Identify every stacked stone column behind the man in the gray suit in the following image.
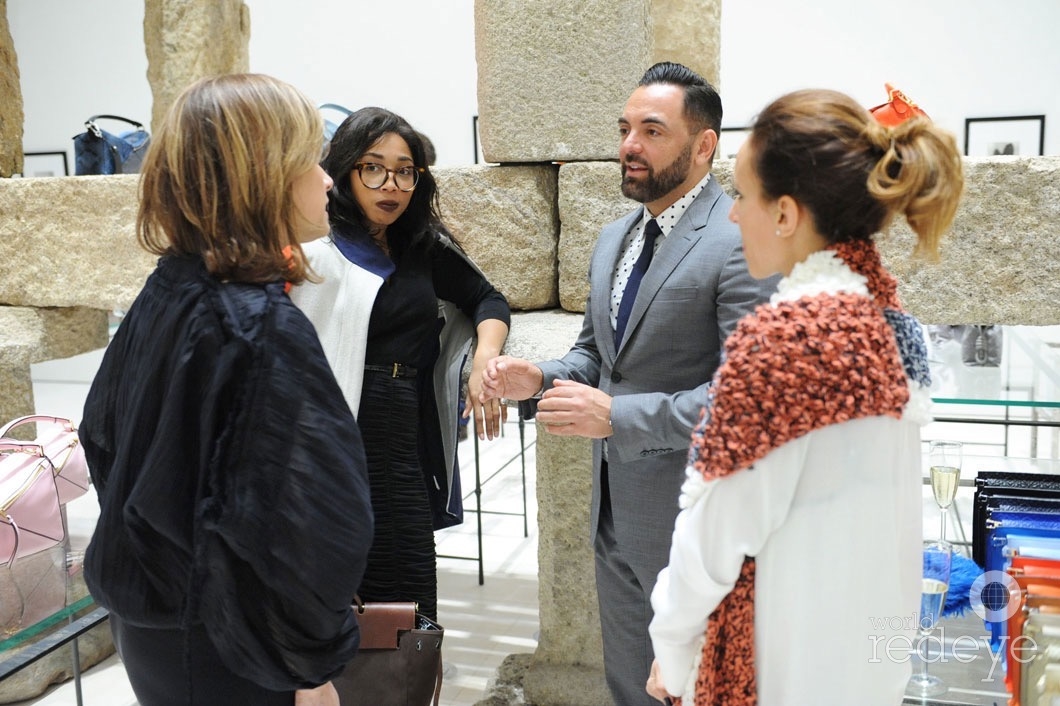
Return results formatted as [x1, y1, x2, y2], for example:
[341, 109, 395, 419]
[475, 0, 721, 706]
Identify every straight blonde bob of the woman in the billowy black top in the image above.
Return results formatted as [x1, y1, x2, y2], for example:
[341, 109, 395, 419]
[137, 73, 323, 284]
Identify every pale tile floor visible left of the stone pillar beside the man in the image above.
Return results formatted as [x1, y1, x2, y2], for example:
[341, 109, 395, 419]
[17, 351, 538, 706]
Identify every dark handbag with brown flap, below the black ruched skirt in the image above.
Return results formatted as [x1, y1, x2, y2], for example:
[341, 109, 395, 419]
[332, 598, 445, 706]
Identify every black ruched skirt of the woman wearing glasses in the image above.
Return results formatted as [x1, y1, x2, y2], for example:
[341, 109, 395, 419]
[357, 370, 438, 620]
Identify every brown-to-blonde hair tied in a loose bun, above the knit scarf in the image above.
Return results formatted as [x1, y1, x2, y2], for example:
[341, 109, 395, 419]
[749, 89, 965, 259]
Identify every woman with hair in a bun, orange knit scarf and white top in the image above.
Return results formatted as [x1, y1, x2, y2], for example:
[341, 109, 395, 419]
[648, 90, 964, 706]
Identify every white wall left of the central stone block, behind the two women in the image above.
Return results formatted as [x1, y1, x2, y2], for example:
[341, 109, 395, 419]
[7, 0, 477, 167]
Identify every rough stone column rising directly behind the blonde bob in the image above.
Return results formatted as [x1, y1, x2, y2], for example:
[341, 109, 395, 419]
[143, 0, 250, 128]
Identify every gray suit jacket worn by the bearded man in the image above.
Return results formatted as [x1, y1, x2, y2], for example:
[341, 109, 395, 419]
[540, 178, 777, 572]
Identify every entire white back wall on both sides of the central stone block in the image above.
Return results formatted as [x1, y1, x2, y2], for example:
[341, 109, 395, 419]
[7, 0, 1060, 169]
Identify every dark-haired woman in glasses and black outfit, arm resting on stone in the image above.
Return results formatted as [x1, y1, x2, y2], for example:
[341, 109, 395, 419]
[292, 107, 511, 619]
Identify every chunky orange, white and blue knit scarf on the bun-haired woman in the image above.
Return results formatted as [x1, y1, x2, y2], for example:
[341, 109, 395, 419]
[682, 242, 930, 706]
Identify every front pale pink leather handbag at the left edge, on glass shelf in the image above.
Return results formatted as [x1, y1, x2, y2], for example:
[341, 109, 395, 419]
[0, 440, 66, 566]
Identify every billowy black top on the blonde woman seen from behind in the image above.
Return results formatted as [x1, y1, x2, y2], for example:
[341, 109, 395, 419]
[78, 258, 372, 690]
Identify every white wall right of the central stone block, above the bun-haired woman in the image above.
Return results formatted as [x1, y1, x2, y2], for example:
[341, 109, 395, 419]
[721, 0, 1060, 155]
